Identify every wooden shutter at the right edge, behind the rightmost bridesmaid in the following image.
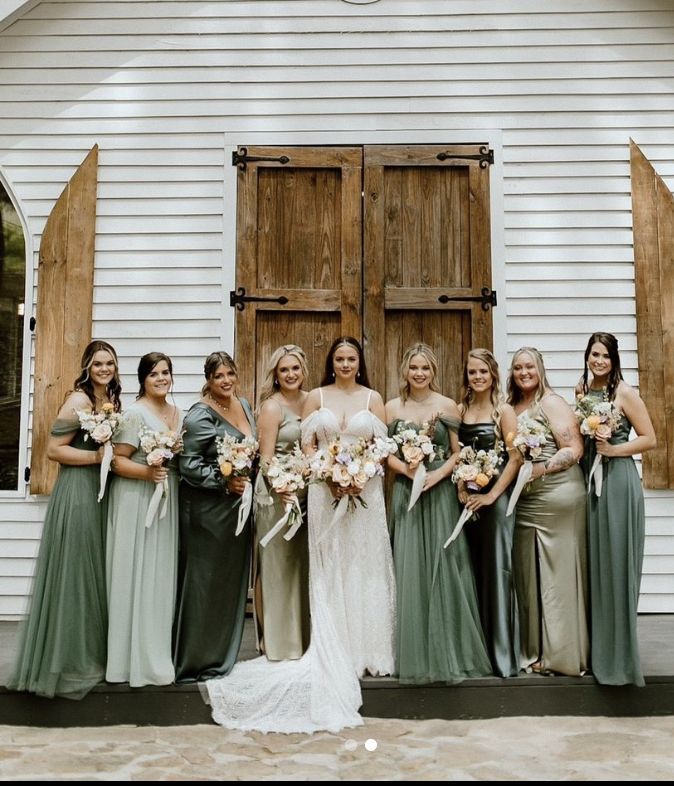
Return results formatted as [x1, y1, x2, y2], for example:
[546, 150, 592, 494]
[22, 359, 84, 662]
[630, 140, 674, 488]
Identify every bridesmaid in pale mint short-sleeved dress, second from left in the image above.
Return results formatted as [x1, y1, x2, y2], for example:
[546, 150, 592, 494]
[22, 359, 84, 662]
[105, 352, 182, 687]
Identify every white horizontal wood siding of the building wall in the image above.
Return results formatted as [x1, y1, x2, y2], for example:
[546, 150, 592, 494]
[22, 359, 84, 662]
[0, 0, 674, 617]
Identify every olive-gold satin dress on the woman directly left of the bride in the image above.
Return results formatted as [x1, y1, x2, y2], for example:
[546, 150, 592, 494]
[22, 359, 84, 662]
[255, 407, 310, 660]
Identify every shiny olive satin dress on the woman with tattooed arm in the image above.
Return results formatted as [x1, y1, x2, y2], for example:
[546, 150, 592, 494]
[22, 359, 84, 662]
[513, 406, 589, 676]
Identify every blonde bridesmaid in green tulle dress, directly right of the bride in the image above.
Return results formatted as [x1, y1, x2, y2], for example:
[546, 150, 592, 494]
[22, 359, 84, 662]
[386, 344, 491, 683]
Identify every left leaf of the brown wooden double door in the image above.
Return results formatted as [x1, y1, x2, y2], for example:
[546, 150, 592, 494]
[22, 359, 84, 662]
[234, 147, 362, 397]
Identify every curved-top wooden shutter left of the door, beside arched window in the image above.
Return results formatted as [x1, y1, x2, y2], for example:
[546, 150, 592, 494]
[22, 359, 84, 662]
[30, 145, 98, 494]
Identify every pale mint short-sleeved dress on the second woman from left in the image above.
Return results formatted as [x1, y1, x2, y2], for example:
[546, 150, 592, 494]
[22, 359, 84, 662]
[106, 402, 182, 687]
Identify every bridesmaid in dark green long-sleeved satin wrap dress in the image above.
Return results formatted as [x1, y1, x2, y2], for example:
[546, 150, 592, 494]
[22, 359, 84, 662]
[173, 352, 255, 682]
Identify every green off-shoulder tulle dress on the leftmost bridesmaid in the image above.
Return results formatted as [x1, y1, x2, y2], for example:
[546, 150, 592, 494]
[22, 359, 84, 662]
[7, 419, 107, 699]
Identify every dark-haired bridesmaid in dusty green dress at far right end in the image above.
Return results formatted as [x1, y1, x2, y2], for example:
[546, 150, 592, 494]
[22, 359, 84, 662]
[577, 333, 656, 685]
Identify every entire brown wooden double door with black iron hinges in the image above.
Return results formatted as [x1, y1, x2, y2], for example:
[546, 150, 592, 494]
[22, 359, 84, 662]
[230, 144, 496, 400]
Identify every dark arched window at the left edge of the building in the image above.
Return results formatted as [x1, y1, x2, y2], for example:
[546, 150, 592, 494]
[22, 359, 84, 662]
[0, 181, 26, 491]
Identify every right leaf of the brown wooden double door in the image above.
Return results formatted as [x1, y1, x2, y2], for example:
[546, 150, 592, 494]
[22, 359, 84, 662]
[364, 145, 492, 398]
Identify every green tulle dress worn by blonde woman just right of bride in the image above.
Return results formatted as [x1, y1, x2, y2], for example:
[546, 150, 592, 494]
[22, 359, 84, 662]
[389, 418, 492, 684]
